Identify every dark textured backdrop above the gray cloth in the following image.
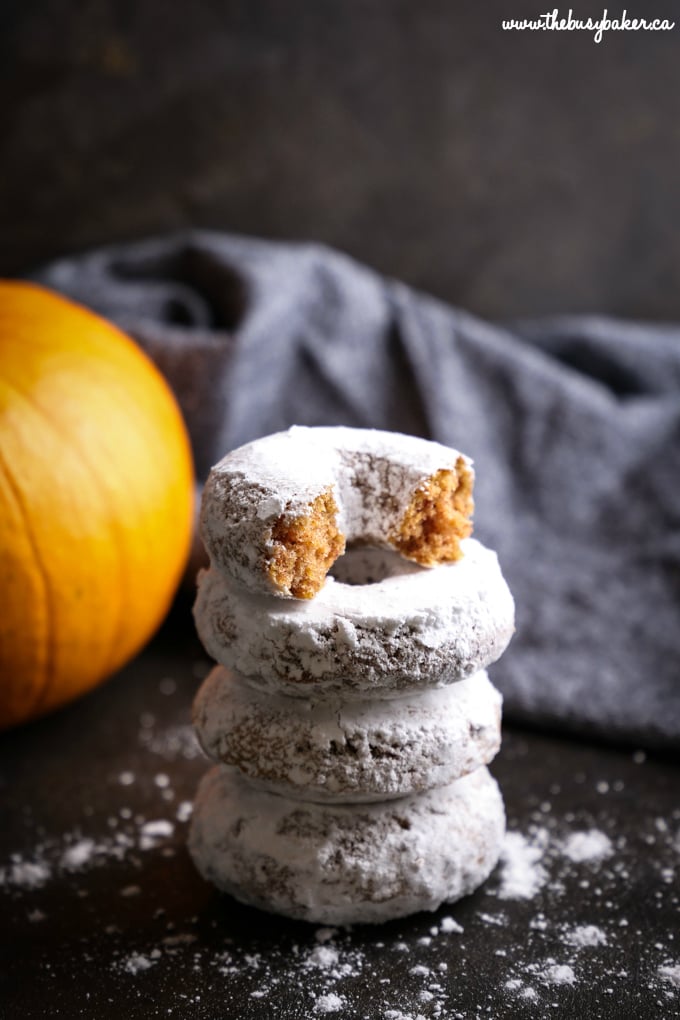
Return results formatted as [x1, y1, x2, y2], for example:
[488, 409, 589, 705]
[0, 0, 680, 319]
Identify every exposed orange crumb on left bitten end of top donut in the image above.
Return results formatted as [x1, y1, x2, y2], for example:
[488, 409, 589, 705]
[268, 490, 345, 599]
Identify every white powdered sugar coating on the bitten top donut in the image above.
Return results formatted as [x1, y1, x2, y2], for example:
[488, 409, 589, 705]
[201, 426, 472, 597]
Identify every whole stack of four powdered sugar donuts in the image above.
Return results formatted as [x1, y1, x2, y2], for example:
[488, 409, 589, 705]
[190, 427, 514, 924]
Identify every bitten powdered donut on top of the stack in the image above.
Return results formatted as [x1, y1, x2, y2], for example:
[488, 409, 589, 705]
[201, 425, 474, 599]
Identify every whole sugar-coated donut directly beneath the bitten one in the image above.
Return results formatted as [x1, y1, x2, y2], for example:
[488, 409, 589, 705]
[195, 539, 514, 700]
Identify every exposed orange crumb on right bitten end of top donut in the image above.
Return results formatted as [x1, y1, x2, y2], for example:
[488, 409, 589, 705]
[390, 457, 474, 566]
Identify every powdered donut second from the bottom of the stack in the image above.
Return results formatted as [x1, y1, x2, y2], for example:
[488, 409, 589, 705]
[194, 666, 502, 803]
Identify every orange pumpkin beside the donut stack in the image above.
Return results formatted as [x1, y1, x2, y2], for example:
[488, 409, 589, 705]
[0, 282, 194, 727]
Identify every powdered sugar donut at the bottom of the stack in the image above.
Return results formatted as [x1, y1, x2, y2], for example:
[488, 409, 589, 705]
[189, 765, 505, 924]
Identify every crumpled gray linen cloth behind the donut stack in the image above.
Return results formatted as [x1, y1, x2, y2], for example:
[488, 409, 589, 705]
[34, 233, 680, 748]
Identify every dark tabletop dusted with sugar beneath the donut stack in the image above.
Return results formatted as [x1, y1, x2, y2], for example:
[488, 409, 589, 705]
[0, 595, 680, 1020]
